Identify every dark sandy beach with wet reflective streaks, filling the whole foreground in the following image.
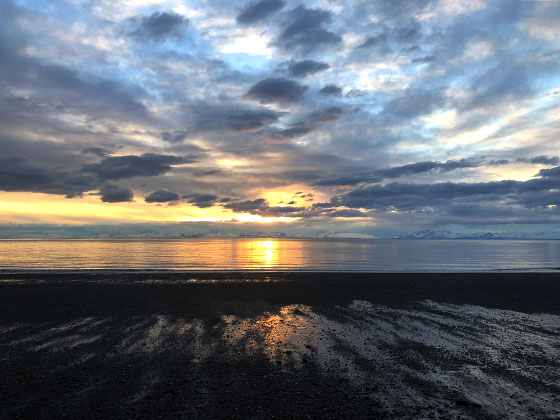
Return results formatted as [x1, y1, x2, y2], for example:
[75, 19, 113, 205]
[0, 273, 560, 419]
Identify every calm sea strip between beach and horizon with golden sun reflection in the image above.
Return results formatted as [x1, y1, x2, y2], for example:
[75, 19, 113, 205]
[0, 239, 560, 272]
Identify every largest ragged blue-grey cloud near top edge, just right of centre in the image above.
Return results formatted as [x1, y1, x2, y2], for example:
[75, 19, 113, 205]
[277, 6, 342, 51]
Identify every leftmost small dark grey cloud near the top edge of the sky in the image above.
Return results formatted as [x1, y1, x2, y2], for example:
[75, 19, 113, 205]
[131, 12, 189, 41]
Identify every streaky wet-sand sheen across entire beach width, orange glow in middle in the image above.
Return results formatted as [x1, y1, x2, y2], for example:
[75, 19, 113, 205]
[0, 300, 560, 418]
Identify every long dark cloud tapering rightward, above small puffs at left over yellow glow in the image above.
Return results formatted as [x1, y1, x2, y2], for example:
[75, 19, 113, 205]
[82, 153, 192, 181]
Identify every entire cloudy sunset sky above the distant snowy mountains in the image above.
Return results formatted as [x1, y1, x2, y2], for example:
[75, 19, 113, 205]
[0, 0, 560, 236]
